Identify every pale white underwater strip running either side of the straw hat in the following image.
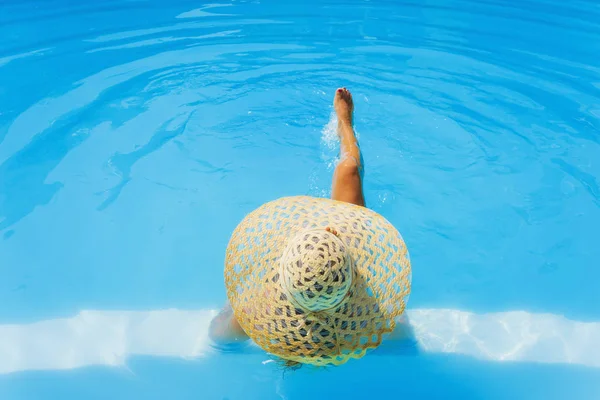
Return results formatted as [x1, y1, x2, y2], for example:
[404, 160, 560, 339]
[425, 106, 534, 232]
[0, 309, 600, 374]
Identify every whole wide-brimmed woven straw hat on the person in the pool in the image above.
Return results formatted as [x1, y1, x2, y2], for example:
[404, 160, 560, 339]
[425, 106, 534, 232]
[225, 196, 411, 366]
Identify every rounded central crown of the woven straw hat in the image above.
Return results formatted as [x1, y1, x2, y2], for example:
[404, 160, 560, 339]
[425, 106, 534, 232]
[281, 229, 353, 312]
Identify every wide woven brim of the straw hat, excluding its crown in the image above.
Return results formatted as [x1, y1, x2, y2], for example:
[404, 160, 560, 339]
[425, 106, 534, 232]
[225, 196, 411, 365]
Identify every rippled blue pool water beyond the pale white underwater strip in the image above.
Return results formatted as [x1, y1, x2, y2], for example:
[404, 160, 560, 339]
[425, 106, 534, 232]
[0, 0, 600, 328]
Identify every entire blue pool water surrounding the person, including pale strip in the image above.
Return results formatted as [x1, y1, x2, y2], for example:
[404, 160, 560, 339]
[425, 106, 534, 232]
[0, 0, 600, 400]
